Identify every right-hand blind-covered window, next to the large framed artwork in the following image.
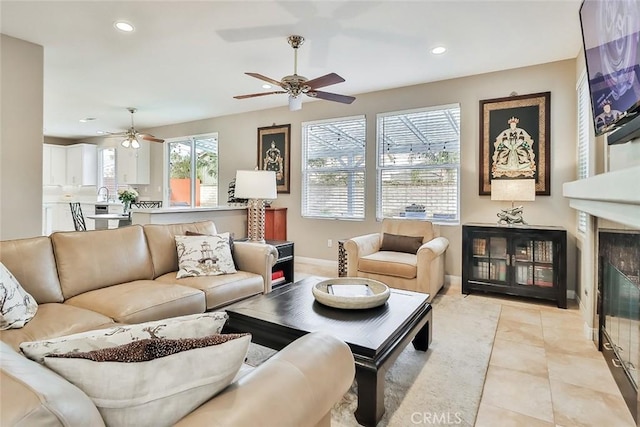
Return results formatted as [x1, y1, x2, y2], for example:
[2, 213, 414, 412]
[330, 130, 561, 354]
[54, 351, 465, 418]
[376, 104, 460, 223]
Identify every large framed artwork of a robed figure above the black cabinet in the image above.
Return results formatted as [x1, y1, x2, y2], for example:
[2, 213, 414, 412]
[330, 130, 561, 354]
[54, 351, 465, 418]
[479, 92, 551, 196]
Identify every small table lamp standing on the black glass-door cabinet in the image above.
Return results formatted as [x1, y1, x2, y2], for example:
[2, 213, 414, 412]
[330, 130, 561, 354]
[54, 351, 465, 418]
[491, 179, 536, 225]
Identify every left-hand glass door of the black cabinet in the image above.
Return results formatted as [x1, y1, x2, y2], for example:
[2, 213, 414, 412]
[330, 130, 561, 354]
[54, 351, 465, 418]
[472, 236, 508, 282]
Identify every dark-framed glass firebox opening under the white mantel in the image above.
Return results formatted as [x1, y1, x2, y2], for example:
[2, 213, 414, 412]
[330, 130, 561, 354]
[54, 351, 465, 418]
[598, 228, 640, 423]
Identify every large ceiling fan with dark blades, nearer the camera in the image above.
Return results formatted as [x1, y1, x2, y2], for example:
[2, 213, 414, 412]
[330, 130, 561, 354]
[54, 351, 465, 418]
[234, 35, 356, 111]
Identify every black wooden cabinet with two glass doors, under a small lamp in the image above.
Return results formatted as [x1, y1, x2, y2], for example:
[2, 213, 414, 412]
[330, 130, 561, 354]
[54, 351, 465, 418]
[462, 224, 567, 308]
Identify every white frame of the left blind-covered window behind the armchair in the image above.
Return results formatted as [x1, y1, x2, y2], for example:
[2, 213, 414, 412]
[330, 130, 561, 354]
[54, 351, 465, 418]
[300, 115, 367, 221]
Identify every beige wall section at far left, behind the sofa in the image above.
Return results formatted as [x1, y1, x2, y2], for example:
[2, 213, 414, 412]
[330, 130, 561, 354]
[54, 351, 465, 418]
[0, 34, 44, 240]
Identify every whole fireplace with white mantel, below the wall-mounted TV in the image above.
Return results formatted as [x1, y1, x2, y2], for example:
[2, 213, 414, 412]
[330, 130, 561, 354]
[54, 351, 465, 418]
[563, 164, 640, 427]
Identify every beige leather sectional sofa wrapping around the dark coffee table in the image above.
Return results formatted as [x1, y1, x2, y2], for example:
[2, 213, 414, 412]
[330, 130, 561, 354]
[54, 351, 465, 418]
[0, 221, 354, 426]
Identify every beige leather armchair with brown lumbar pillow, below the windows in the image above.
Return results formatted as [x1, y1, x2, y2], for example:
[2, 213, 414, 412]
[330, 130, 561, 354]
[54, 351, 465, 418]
[344, 219, 449, 301]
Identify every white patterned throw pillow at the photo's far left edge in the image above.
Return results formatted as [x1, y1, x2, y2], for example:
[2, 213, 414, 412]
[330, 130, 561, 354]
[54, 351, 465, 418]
[0, 262, 38, 330]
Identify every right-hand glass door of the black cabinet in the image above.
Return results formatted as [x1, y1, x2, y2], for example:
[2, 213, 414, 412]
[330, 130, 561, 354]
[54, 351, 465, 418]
[513, 239, 554, 288]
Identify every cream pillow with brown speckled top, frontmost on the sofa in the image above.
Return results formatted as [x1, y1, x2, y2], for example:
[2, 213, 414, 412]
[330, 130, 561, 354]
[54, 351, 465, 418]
[44, 334, 251, 426]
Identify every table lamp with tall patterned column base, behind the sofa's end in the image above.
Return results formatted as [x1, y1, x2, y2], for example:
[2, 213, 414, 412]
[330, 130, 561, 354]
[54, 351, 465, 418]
[235, 170, 278, 243]
